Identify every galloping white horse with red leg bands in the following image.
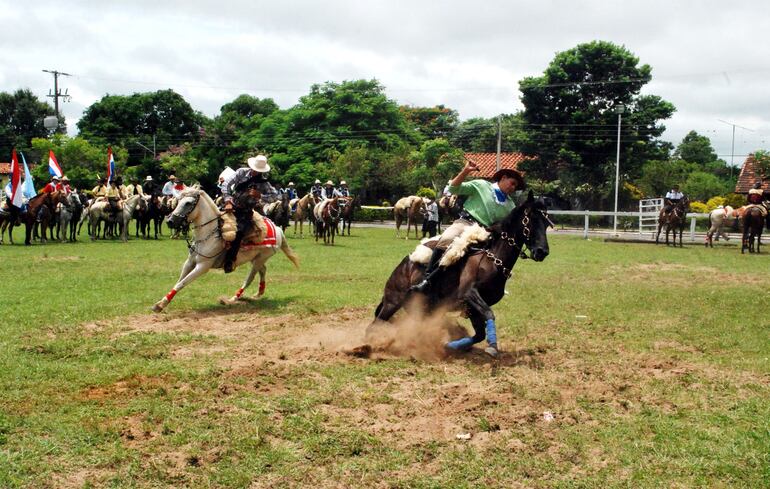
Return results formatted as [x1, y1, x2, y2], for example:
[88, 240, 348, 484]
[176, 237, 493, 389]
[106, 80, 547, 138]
[153, 188, 299, 312]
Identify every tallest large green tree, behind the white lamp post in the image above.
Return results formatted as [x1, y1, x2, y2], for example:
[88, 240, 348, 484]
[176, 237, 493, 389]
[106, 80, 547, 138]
[519, 41, 675, 205]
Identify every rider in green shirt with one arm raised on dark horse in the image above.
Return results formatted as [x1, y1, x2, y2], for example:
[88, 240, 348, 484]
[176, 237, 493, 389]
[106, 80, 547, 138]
[411, 160, 526, 292]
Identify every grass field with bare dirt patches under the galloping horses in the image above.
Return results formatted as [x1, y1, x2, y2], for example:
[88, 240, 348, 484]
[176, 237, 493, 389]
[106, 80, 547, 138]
[0, 229, 770, 487]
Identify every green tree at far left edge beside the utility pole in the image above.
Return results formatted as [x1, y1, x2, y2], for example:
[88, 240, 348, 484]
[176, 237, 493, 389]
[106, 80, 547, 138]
[0, 89, 55, 161]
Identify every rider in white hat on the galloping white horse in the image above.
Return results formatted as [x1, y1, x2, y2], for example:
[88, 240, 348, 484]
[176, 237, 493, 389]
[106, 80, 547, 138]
[222, 155, 279, 273]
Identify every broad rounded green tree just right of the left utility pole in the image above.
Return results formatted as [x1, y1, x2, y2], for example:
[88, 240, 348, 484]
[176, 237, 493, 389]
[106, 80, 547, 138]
[78, 90, 206, 165]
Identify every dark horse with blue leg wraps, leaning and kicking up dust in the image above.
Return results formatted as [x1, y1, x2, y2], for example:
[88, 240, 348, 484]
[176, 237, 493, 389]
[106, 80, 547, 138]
[372, 192, 553, 357]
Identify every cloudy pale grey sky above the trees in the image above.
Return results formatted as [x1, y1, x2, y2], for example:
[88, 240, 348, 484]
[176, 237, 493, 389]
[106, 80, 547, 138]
[0, 0, 770, 164]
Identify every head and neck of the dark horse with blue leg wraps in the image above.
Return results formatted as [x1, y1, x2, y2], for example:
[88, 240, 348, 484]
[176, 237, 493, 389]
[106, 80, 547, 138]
[492, 190, 554, 261]
